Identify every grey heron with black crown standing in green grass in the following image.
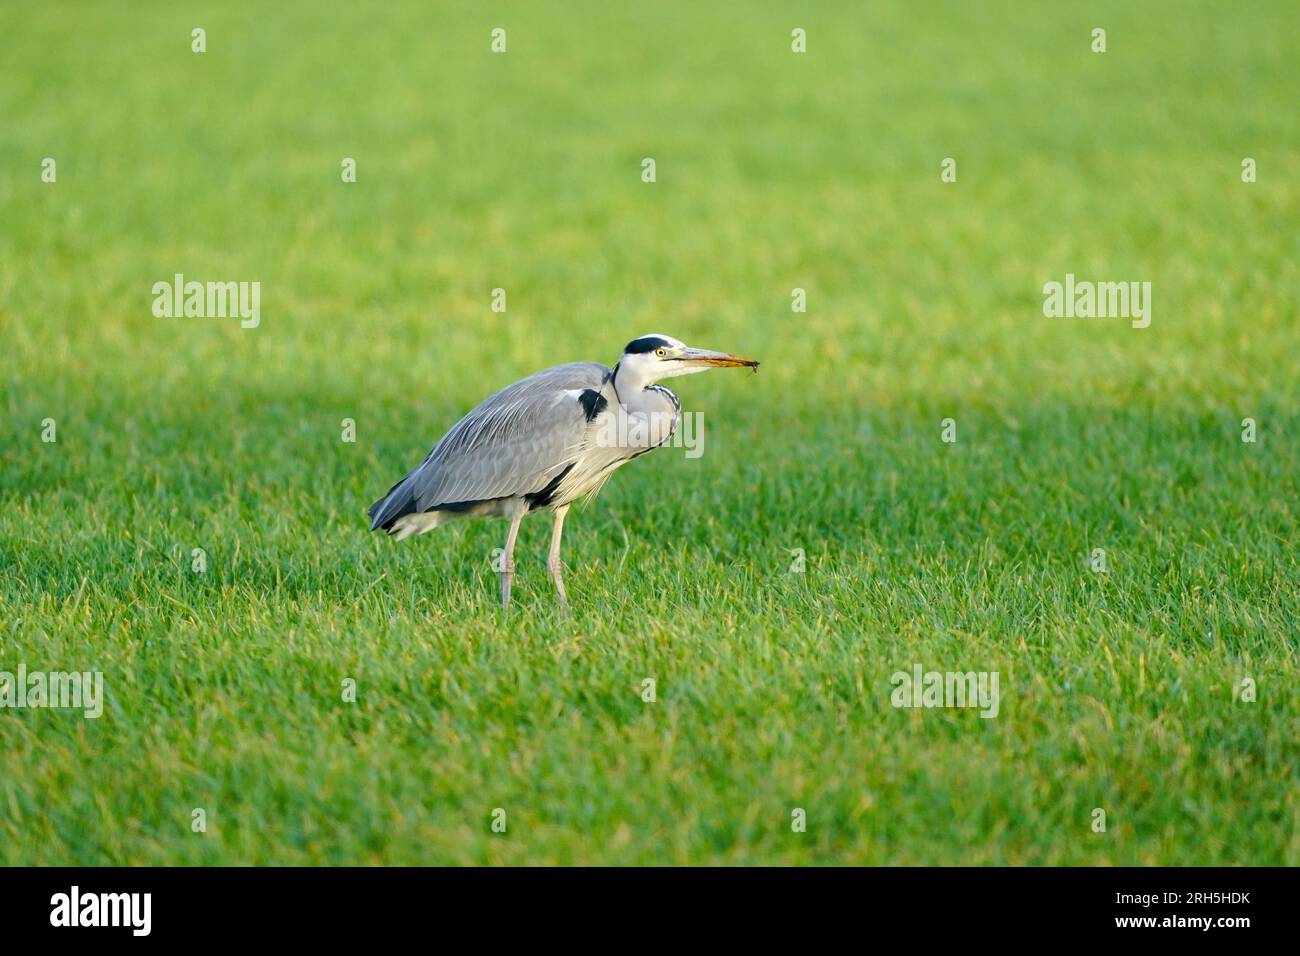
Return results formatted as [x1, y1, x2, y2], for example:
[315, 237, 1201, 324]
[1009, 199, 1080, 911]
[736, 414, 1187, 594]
[369, 334, 758, 609]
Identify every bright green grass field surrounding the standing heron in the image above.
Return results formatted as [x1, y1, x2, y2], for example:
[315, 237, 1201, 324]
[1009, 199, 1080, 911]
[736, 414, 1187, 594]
[0, 0, 1300, 865]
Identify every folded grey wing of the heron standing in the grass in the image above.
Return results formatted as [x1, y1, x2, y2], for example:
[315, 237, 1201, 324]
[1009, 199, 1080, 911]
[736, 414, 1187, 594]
[371, 362, 611, 528]
